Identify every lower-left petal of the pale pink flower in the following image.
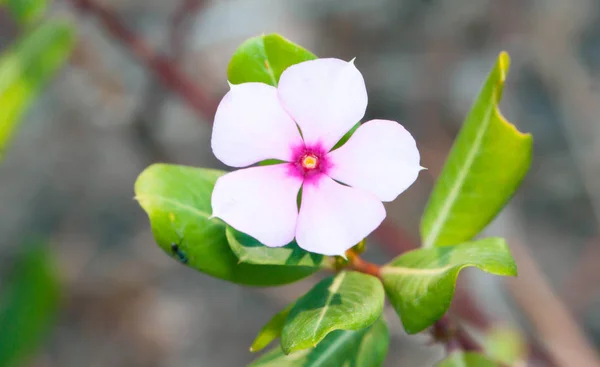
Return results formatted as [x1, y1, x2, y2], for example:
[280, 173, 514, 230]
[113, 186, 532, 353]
[212, 164, 302, 247]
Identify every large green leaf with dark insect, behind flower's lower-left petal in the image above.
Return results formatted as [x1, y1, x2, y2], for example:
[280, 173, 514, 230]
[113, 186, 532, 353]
[135, 164, 317, 286]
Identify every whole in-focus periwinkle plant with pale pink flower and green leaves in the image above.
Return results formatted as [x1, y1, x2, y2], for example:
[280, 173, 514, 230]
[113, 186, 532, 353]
[136, 35, 532, 367]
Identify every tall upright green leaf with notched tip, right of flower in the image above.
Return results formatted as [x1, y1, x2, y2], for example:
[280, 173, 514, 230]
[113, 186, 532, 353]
[421, 52, 532, 247]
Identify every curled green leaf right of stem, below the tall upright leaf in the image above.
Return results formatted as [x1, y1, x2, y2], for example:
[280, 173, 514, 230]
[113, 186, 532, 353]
[381, 238, 517, 334]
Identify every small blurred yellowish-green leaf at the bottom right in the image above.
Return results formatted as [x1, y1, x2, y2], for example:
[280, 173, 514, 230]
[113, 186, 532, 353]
[483, 326, 527, 366]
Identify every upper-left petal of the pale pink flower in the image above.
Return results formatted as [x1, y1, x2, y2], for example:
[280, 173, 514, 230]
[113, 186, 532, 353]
[211, 83, 302, 167]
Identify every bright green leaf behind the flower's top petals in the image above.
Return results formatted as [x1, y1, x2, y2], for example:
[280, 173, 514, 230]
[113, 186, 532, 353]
[227, 34, 317, 86]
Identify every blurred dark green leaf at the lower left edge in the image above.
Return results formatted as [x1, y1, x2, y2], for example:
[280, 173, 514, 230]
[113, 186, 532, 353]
[0, 247, 60, 367]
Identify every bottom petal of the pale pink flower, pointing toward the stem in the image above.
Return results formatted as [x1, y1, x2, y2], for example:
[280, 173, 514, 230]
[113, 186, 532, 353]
[296, 175, 385, 256]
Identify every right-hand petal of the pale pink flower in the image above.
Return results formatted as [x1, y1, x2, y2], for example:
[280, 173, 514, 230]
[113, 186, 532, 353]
[327, 120, 423, 201]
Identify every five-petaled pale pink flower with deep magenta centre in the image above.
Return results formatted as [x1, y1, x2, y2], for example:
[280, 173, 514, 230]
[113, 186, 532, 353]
[212, 59, 422, 255]
